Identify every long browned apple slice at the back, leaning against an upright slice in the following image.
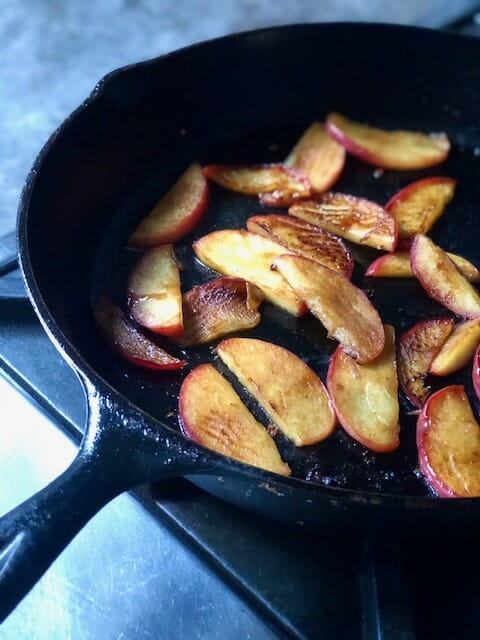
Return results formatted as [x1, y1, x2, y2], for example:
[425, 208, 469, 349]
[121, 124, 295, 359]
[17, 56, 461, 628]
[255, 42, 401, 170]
[203, 164, 312, 207]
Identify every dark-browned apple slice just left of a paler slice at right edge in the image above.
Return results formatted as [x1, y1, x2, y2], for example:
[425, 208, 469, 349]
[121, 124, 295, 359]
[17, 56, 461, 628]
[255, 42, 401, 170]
[397, 318, 454, 408]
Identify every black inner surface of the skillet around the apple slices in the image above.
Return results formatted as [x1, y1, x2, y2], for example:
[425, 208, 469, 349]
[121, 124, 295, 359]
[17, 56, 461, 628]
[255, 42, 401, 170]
[20, 25, 480, 496]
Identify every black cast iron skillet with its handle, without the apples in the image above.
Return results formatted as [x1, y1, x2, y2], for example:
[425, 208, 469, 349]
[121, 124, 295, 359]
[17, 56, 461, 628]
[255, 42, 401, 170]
[0, 24, 480, 617]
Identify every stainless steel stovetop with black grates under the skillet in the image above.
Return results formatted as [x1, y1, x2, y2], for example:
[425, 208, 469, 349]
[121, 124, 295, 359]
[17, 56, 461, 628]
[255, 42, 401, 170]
[0, 6, 480, 640]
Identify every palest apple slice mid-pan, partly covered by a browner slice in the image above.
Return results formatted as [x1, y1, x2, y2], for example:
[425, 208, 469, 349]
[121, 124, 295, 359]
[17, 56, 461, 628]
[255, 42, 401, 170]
[193, 229, 307, 316]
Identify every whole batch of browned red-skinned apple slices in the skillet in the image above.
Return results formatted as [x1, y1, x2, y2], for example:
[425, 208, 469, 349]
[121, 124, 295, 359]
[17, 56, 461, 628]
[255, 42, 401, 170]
[94, 113, 480, 497]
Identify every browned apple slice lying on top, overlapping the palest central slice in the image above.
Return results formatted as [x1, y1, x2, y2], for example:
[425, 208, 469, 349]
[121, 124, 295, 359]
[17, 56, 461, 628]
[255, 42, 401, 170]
[274, 255, 385, 364]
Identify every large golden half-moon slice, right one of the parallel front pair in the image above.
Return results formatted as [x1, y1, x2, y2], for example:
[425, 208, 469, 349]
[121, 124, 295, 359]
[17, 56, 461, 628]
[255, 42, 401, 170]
[216, 338, 335, 447]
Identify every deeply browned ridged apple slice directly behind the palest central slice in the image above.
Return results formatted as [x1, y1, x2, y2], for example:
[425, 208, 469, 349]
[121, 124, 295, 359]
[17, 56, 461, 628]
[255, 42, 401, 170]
[247, 214, 354, 278]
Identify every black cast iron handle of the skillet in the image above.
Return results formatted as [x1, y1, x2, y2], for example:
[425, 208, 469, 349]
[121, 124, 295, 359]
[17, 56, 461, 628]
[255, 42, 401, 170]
[0, 450, 123, 623]
